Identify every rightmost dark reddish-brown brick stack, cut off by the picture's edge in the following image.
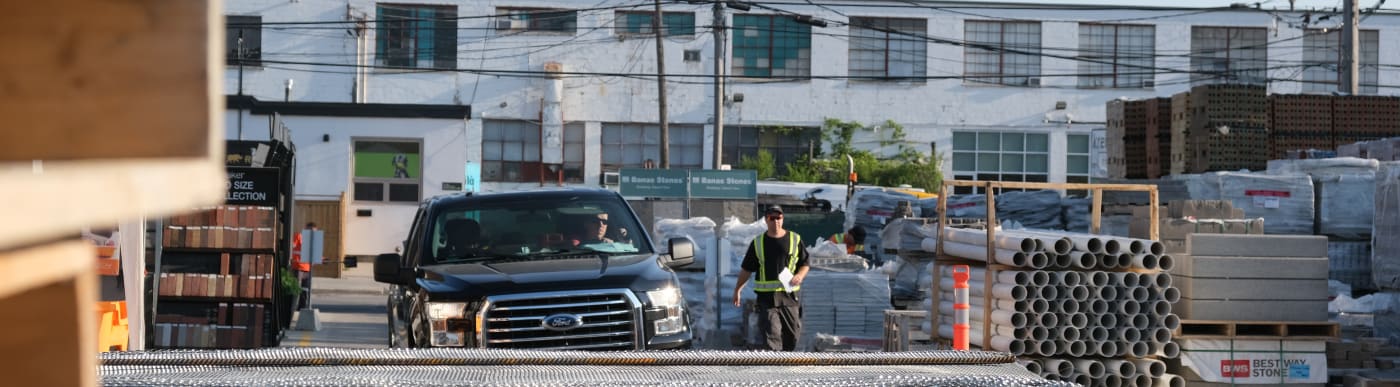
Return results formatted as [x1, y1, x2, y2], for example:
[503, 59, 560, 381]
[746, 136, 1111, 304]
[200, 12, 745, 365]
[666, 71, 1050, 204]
[1333, 95, 1400, 144]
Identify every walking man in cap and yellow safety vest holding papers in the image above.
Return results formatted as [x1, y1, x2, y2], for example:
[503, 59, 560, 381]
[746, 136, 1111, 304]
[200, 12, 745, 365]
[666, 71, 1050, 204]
[734, 206, 808, 351]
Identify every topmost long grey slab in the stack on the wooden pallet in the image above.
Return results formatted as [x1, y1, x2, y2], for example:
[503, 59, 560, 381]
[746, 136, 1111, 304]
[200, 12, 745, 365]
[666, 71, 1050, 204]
[1186, 234, 1327, 258]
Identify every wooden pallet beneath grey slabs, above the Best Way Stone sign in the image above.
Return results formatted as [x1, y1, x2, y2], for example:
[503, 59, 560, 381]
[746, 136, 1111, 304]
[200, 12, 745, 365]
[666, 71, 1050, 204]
[1172, 320, 1341, 339]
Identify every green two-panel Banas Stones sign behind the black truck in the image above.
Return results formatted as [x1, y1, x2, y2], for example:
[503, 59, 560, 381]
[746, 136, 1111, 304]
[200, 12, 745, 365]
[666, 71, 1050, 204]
[617, 168, 759, 201]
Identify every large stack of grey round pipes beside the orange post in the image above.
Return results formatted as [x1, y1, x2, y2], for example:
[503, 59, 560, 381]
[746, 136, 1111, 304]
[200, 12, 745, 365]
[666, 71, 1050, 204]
[924, 229, 1184, 387]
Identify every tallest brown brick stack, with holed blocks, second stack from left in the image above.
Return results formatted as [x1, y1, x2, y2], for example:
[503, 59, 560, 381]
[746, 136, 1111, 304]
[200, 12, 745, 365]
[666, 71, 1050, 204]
[1172, 84, 1268, 174]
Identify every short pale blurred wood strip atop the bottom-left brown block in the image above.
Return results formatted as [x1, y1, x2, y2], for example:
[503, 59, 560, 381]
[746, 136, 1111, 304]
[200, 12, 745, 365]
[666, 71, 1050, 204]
[0, 241, 97, 299]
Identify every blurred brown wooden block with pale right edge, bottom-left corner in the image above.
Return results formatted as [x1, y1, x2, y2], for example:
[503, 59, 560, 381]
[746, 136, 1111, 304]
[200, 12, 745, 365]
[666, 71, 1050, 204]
[0, 253, 98, 386]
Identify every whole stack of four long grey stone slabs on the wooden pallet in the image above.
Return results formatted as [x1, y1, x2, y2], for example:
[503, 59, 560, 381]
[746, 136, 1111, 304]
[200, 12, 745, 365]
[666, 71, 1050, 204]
[1172, 234, 1329, 321]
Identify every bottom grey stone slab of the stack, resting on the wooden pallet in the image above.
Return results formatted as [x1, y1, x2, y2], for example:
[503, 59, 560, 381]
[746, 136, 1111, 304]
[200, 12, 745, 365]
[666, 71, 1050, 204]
[1172, 299, 1327, 321]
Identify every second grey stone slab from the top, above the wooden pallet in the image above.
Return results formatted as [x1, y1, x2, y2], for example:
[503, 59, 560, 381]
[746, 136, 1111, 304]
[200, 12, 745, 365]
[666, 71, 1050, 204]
[1172, 255, 1327, 279]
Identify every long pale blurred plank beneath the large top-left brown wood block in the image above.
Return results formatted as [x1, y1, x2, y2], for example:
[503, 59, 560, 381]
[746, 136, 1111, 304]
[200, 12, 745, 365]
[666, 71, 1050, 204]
[0, 158, 228, 250]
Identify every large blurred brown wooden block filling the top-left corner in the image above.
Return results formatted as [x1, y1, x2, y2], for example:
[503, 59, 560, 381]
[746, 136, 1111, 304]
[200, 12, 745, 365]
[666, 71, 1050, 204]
[0, 0, 224, 160]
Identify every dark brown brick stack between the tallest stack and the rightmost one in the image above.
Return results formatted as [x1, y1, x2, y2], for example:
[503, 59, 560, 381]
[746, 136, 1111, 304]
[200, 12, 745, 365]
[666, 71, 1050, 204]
[1268, 94, 1336, 160]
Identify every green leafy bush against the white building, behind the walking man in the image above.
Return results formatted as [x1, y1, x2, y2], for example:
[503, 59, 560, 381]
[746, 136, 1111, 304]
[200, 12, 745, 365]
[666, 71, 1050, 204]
[772, 118, 942, 192]
